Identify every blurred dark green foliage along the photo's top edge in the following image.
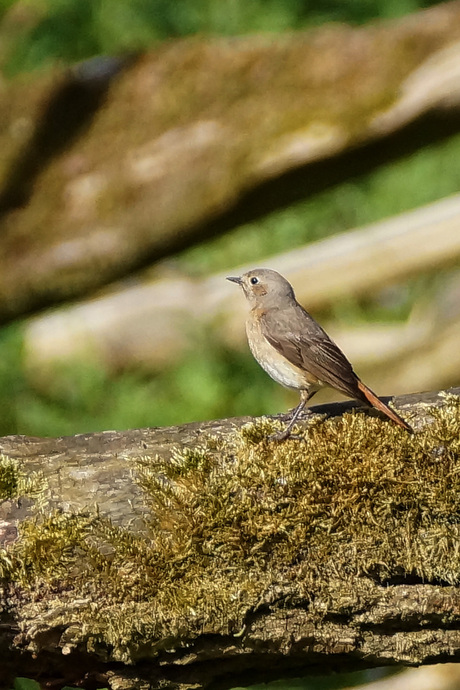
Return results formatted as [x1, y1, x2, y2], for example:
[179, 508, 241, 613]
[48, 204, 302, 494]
[0, 0, 450, 73]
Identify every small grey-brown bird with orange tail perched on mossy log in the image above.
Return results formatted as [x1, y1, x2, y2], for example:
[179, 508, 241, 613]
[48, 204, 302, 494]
[227, 268, 412, 440]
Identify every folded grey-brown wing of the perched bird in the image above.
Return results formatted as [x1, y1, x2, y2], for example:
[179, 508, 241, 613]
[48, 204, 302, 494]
[260, 305, 362, 398]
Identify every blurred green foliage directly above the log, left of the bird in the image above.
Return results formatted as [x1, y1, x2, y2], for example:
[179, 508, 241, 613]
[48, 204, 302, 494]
[0, 324, 296, 436]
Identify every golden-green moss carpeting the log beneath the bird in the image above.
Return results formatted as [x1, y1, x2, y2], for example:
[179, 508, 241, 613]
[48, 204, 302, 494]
[4, 396, 460, 662]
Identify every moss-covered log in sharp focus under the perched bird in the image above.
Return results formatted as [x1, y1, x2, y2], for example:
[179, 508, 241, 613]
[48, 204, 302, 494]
[0, 388, 460, 690]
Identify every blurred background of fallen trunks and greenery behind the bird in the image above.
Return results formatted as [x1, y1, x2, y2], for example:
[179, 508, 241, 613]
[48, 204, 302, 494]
[4, 0, 460, 688]
